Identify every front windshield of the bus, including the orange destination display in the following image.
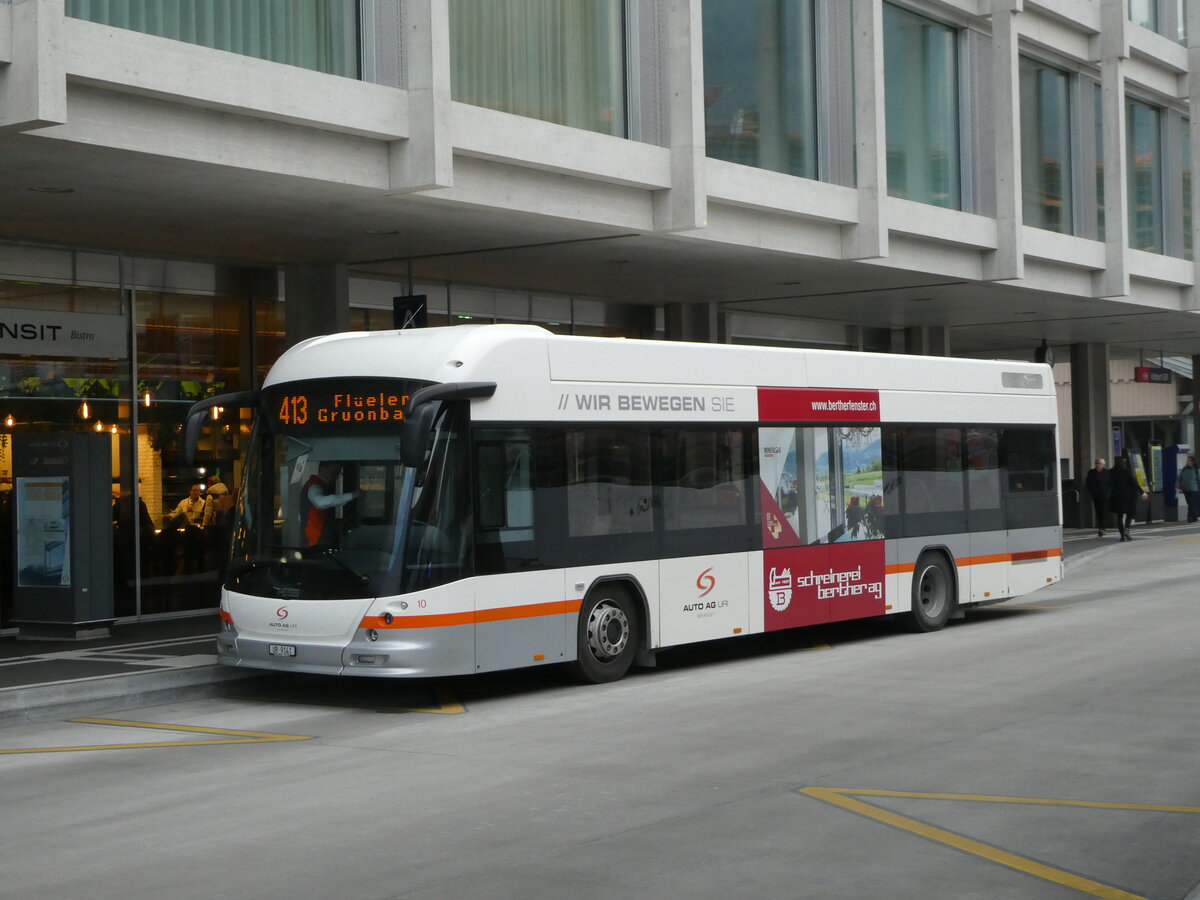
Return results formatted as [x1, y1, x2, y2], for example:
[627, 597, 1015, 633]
[226, 379, 472, 600]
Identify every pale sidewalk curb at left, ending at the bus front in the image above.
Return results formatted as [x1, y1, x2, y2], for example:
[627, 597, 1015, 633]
[0, 664, 264, 727]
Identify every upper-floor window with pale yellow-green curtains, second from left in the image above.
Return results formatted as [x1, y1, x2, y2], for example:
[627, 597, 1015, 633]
[450, 0, 628, 137]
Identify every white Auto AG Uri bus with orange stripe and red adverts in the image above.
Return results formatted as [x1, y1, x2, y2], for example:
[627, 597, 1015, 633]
[188, 325, 1062, 683]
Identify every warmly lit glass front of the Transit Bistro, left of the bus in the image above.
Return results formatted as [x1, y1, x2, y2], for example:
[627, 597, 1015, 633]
[0, 251, 274, 628]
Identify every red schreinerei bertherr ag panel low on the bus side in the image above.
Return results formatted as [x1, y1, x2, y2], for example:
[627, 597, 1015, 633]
[762, 541, 887, 631]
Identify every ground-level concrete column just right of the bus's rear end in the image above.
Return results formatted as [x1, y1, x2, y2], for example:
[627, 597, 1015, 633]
[1060, 343, 1114, 528]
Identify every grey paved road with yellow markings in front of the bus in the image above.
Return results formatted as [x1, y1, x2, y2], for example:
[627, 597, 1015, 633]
[0, 533, 1200, 900]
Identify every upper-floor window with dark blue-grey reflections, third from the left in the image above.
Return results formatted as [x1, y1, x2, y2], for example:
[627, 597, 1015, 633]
[702, 0, 817, 178]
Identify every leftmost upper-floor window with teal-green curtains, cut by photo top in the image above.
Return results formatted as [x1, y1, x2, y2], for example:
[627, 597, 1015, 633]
[66, 0, 360, 78]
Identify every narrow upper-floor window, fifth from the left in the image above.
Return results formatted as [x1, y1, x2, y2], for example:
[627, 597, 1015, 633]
[1020, 58, 1074, 234]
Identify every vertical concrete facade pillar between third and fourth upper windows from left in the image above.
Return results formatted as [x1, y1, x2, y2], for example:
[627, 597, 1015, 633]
[841, 0, 888, 259]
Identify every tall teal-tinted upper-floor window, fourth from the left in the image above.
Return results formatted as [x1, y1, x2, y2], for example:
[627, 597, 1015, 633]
[883, 4, 962, 209]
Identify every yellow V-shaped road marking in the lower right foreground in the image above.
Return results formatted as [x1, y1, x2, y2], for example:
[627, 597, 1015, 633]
[799, 787, 1200, 900]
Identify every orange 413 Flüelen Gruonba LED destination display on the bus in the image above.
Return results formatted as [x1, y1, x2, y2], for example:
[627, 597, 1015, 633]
[265, 380, 421, 432]
